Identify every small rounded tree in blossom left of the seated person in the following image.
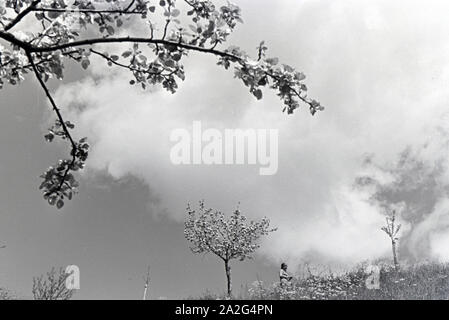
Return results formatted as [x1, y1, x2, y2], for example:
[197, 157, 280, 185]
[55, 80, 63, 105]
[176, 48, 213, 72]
[184, 201, 276, 296]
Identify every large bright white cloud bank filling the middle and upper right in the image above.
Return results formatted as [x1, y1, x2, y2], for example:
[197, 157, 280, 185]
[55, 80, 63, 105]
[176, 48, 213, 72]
[57, 1, 449, 263]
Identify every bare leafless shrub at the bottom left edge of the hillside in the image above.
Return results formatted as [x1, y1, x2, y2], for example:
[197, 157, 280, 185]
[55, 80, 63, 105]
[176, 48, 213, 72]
[33, 267, 74, 300]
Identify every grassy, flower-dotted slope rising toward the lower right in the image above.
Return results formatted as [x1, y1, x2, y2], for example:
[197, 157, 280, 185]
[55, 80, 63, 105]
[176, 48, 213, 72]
[194, 263, 449, 300]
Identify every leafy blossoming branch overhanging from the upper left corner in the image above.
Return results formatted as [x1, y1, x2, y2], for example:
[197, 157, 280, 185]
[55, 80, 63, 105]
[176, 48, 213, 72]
[0, 0, 324, 208]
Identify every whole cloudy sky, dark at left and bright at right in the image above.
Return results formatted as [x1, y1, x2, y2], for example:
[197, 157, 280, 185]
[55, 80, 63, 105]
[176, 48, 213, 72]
[0, 0, 449, 299]
